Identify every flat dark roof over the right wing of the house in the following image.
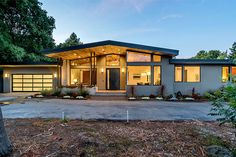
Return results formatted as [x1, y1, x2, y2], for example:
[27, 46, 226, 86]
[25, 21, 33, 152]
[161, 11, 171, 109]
[169, 59, 236, 65]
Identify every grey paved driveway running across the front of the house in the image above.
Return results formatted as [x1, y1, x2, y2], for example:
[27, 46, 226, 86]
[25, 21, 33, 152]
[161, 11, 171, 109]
[2, 99, 215, 121]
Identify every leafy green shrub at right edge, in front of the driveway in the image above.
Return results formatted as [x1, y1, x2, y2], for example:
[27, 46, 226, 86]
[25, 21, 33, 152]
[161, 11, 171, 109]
[210, 83, 236, 136]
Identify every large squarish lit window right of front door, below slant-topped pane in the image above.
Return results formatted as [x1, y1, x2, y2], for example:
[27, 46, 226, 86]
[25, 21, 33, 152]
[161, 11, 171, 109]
[128, 66, 151, 85]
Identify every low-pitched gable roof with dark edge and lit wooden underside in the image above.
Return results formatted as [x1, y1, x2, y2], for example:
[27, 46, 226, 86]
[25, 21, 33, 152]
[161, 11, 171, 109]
[42, 40, 179, 60]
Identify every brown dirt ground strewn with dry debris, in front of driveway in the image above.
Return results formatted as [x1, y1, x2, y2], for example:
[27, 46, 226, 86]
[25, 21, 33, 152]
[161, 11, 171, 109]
[5, 119, 236, 157]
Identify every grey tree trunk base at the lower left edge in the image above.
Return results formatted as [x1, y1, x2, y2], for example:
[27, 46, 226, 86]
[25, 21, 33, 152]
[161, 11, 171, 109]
[0, 107, 12, 157]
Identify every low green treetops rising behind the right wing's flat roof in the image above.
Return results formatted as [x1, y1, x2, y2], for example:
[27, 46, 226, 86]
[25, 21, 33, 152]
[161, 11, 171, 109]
[192, 50, 228, 59]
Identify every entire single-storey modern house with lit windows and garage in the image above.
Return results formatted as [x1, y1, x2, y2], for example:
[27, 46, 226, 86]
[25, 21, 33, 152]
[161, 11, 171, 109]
[0, 40, 236, 96]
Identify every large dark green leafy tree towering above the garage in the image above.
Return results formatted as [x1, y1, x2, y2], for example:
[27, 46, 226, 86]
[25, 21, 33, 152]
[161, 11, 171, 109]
[0, 0, 55, 62]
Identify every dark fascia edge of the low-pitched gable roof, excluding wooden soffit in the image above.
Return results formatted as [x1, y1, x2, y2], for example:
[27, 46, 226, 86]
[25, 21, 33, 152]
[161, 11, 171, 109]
[41, 40, 179, 56]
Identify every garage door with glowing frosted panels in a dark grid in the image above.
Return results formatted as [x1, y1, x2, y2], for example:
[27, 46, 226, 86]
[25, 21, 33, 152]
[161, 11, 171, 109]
[12, 74, 53, 92]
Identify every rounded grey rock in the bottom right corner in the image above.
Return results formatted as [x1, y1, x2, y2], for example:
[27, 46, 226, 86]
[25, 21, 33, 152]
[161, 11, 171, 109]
[206, 145, 233, 157]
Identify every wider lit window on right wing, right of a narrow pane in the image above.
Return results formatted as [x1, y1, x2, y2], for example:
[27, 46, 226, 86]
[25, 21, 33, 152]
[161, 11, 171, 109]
[184, 66, 200, 82]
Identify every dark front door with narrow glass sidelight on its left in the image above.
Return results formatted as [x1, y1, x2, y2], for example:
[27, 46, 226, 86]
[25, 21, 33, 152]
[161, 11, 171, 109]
[106, 68, 120, 90]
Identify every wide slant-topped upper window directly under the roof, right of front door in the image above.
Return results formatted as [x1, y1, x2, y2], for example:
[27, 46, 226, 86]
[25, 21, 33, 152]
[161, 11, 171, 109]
[127, 52, 151, 62]
